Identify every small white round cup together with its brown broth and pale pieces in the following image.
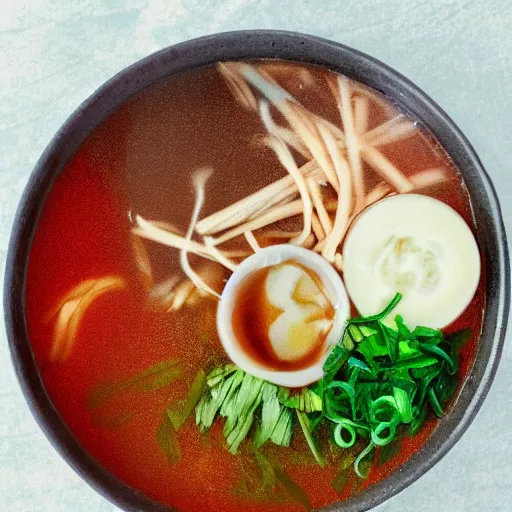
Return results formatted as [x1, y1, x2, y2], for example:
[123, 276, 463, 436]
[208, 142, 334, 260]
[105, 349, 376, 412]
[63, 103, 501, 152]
[217, 244, 349, 387]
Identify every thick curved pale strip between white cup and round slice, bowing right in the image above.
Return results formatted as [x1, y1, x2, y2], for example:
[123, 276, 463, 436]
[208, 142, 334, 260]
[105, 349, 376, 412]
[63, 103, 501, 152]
[320, 122, 352, 263]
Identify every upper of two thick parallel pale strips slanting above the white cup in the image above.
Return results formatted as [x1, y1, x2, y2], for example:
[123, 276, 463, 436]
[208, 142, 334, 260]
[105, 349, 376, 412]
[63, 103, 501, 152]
[196, 161, 319, 235]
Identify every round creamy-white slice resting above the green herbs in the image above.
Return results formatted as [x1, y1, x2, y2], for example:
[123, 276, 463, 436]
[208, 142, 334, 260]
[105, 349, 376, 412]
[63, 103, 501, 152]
[343, 194, 480, 328]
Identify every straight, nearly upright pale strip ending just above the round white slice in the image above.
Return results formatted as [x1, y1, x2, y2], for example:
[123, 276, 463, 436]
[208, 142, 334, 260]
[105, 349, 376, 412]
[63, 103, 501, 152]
[338, 76, 365, 210]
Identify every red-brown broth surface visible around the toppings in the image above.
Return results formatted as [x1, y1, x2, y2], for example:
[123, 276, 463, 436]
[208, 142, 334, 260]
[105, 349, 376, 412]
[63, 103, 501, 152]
[26, 64, 485, 512]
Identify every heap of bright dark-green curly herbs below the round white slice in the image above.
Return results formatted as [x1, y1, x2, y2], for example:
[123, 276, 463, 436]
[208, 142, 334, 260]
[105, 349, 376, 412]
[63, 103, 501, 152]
[314, 295, 467, 483]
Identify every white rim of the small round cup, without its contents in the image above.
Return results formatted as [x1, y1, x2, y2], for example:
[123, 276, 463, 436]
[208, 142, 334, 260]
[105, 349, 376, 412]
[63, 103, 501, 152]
[217, 244, 350, 388]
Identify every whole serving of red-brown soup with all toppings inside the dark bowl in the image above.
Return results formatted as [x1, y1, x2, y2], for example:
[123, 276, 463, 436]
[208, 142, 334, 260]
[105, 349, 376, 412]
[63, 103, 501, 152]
[26, 61, 485, 512]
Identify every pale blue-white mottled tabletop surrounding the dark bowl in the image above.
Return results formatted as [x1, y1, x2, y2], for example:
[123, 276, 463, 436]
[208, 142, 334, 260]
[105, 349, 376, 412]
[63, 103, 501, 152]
[0, 0, 512, 512]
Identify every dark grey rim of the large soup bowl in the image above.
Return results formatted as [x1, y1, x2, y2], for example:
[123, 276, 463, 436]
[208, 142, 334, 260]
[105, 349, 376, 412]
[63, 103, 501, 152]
[4, 30, 510, 512]
